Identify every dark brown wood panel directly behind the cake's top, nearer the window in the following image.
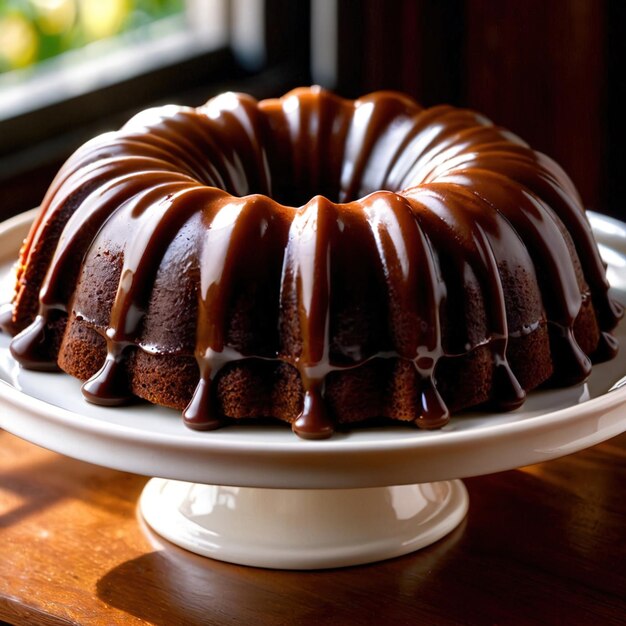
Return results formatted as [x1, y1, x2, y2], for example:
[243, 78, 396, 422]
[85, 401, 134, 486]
[337, 0, 463, 105]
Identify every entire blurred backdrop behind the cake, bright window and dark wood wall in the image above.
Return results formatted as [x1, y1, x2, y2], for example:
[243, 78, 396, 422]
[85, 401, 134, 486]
[0, 0, 626, 219]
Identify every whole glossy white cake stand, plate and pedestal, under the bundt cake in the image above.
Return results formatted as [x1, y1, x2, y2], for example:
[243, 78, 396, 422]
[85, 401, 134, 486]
[0, 207, 626, 569]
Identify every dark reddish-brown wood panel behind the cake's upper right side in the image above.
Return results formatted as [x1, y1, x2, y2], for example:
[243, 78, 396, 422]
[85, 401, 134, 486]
[465, 0, 606, 210]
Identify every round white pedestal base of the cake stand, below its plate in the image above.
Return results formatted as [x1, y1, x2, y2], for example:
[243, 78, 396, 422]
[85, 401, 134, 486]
[140, 478, 469, 570]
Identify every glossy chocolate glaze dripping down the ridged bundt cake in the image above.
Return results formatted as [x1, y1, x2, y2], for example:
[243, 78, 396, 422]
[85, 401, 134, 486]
[2, 88, 622, 438]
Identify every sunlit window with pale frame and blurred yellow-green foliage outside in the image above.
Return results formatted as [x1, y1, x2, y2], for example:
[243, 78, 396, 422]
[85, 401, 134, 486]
[0, 0, 228, 147]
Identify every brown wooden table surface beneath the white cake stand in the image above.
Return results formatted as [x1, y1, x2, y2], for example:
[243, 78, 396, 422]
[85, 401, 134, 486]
[0, 431, 626, 626]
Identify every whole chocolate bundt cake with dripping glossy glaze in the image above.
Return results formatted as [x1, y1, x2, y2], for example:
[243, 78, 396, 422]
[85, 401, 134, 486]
[3, 87, 622, 438]
